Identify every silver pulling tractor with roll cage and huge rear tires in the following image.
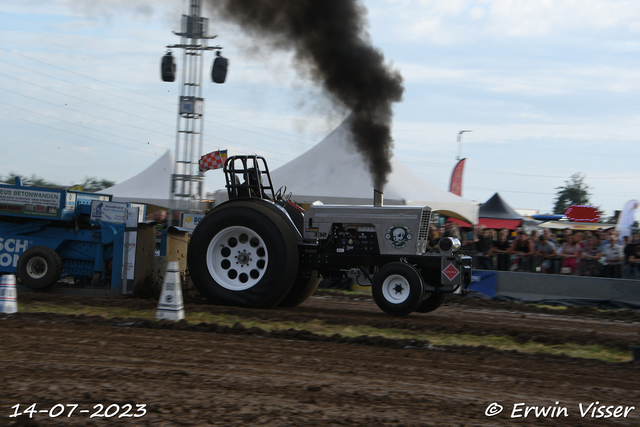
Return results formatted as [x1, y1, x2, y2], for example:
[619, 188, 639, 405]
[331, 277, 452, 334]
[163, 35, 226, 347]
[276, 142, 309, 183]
[187, 155, 472, 316]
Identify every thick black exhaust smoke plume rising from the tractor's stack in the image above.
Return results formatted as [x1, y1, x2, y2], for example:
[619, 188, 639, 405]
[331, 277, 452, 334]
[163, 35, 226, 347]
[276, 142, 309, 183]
[206, 0, 404, 190]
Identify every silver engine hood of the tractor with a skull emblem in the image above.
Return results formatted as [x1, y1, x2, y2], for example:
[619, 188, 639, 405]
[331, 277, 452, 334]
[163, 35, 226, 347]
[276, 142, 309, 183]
[303, 205, 431, 255]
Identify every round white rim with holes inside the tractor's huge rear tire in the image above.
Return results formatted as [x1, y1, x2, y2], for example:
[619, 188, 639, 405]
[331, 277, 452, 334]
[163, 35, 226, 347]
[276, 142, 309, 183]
[207, 226, 269, 291]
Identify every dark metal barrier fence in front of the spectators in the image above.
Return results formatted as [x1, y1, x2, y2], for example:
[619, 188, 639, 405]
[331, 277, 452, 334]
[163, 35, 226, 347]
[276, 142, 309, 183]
[464, 250, 640, 280]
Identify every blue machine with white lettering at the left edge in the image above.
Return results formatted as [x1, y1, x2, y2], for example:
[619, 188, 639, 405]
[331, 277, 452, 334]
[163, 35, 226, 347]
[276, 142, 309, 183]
[0, 179, 138, 295]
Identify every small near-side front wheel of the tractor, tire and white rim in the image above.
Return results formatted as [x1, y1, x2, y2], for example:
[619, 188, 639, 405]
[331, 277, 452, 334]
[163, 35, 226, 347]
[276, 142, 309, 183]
[371, 262, 424, 316]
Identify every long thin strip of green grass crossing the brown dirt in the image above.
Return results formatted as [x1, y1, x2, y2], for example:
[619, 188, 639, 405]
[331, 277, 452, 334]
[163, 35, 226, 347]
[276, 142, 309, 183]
[13, 302, 632, 362]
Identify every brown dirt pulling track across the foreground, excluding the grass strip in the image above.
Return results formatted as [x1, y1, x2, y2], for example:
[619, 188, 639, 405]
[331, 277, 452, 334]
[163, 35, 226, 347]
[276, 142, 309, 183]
[0, 293, 640, 426]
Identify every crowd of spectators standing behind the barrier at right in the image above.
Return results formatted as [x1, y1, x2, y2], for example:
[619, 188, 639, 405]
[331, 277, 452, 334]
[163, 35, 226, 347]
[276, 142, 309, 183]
[429, 224, 640, 279]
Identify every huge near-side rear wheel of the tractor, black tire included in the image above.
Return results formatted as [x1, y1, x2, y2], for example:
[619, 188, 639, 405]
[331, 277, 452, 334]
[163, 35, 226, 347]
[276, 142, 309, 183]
[187, 200, 298, 308]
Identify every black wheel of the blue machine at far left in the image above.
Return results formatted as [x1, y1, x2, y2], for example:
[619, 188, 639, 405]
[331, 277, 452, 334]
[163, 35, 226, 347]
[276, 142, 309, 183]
[16, 246, 62, 289]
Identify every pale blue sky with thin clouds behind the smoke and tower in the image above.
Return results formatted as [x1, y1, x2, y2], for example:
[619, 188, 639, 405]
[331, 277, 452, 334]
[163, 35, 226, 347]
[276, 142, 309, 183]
[0, 0, 640, 216]
